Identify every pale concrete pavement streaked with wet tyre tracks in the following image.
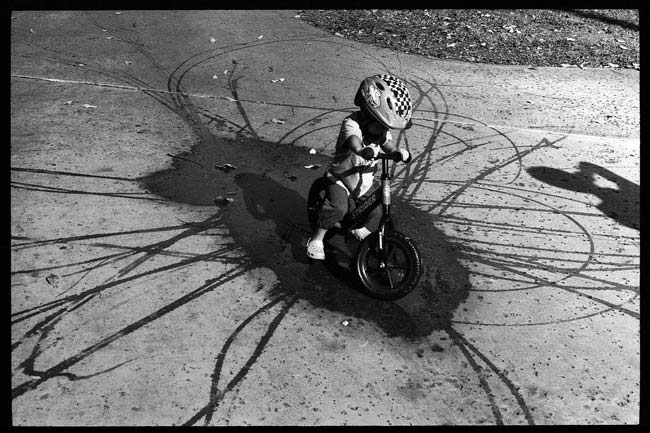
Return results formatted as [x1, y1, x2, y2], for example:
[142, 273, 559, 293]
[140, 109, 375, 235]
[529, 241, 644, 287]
[11, 10, 640, 425]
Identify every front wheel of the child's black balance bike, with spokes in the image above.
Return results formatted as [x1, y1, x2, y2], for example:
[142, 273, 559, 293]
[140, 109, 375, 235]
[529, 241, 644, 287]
[355, 231, 422, 301]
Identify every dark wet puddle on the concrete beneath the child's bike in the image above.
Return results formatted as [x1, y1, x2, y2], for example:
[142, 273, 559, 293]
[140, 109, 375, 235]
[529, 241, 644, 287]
[140, 137, 469, 339]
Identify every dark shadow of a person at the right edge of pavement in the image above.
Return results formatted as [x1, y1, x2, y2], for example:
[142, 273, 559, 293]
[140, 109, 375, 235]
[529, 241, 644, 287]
[526, 162, 641, 230]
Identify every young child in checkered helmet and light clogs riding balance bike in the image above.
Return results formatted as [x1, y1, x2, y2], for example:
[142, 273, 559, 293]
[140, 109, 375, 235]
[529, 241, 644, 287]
[307, 75, 411, 260]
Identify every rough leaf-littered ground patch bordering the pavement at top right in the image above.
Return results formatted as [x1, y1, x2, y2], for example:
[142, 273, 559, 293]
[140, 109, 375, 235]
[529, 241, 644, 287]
[299, 9, 640, 70]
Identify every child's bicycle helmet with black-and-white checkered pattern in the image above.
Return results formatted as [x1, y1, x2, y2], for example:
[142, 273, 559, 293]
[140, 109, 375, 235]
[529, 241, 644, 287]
[354, 74, 411, 129]
